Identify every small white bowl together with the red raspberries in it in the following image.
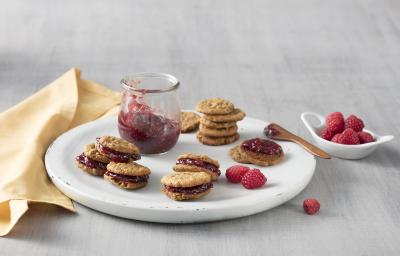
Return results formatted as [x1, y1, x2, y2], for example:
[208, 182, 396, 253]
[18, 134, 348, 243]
[301, 112, 393, 159]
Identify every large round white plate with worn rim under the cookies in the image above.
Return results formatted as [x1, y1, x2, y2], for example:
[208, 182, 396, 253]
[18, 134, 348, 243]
[45, 117, 316, 223]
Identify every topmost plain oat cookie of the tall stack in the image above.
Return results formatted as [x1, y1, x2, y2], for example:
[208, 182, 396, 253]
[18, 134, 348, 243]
[196, 98, 235, 115]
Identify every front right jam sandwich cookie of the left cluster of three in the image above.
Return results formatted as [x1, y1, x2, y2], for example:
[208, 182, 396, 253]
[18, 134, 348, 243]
[104, 162, 150, 189]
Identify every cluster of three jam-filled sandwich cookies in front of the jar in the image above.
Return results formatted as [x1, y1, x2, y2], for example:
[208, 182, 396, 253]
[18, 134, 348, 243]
[75, 136, 150, 189]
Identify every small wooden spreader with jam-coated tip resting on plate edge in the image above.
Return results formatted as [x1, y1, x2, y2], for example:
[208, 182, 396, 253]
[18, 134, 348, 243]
[264, 123, 331, 159]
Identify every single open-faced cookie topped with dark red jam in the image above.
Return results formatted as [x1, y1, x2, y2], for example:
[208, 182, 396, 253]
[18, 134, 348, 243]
[230, 138, 284, 166]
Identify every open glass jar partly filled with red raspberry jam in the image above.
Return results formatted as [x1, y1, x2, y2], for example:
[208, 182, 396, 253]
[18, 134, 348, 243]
[118, 73, 181, 154]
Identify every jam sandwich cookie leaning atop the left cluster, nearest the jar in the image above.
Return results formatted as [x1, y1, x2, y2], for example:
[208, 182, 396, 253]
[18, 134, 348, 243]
[96, 136, 140, 163]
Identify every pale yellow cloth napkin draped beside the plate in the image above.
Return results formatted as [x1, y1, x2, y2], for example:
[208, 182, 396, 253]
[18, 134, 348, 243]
[0, 69, 120, 236]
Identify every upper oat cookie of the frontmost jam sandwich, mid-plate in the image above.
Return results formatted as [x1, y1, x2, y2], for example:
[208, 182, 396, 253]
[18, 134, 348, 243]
[161, 172, 211, 188]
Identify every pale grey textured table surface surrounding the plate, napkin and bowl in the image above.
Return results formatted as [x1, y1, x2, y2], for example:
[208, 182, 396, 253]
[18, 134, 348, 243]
[0, 0, 400, 255]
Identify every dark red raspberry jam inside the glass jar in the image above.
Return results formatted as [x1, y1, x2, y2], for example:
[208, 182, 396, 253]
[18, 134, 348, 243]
[118, 96, 180, 154]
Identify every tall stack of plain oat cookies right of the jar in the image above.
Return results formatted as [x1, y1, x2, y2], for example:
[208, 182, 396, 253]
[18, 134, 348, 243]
[196, 98, 246, 146]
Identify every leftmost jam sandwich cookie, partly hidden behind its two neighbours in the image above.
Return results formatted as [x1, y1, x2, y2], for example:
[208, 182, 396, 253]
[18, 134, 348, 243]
[75, 143, 110, 176]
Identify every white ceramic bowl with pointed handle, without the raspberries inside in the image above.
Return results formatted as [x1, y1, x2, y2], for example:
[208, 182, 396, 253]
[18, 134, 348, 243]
[301, 112, 393, 159]
